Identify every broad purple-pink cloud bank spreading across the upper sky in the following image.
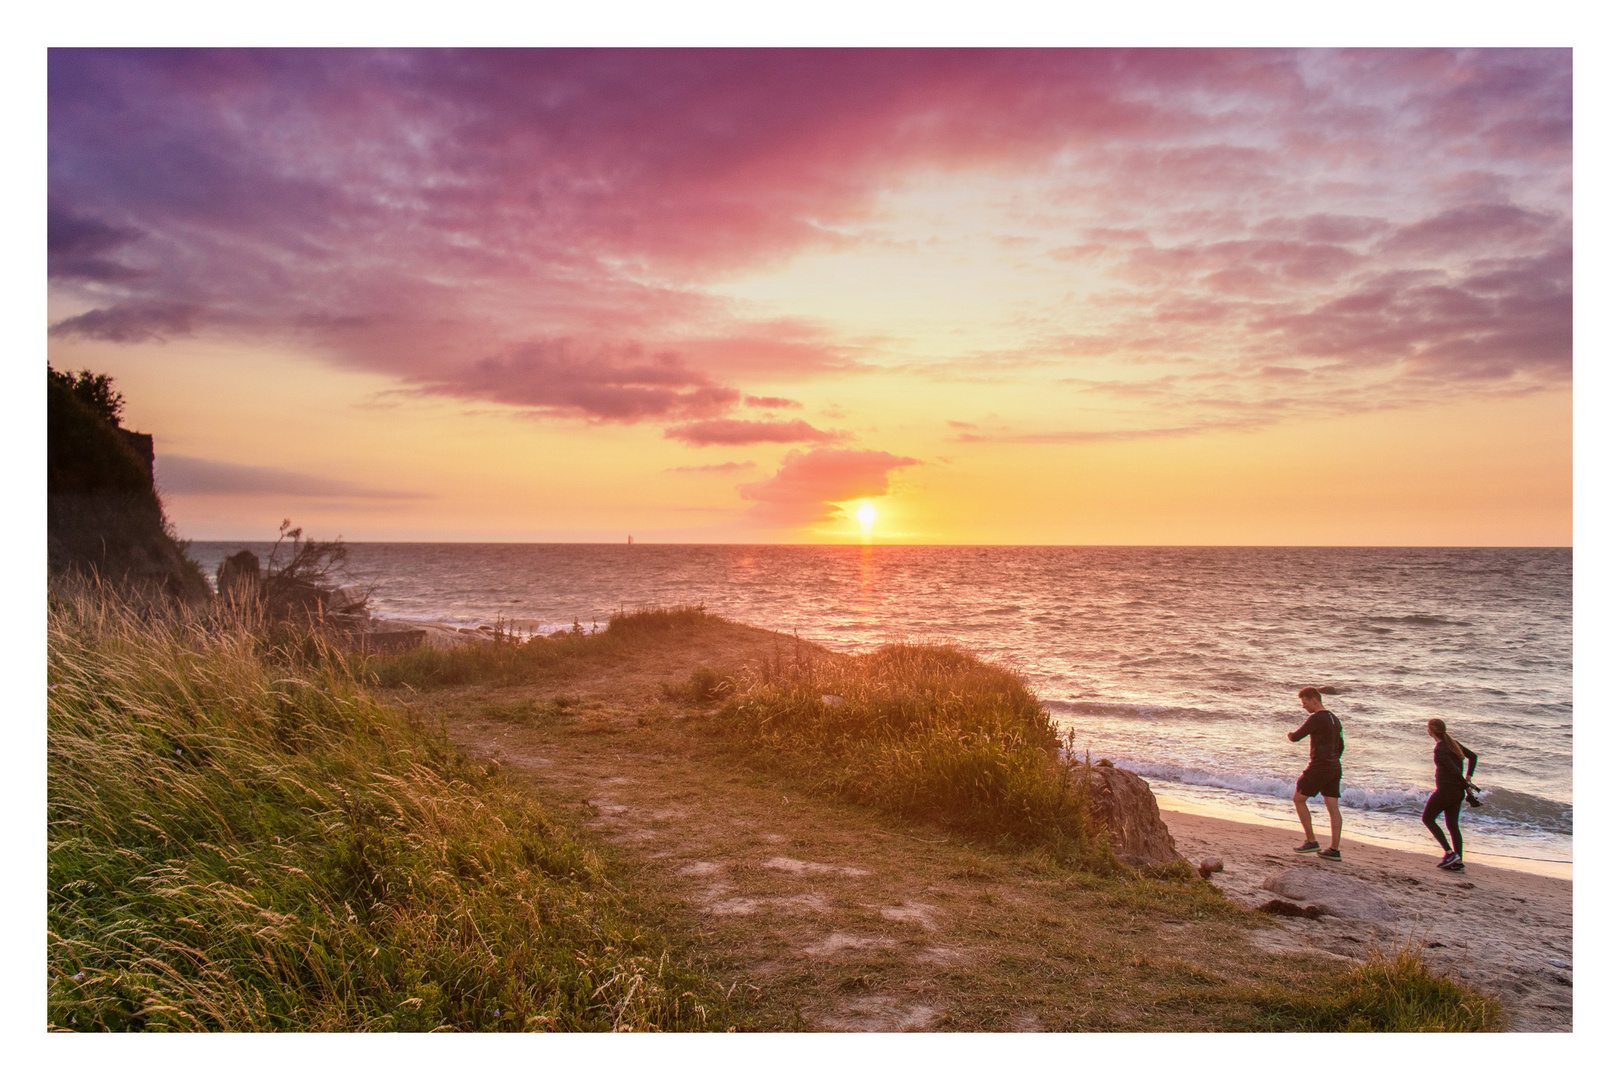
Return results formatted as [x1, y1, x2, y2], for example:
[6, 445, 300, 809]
[47, 49, 1571, 423]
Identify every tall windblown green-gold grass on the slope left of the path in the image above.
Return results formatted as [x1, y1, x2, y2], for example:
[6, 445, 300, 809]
[47, 589, 729, 1031]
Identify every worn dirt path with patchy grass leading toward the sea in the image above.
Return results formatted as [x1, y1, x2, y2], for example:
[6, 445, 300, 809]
[385, 625, 1496, 1031]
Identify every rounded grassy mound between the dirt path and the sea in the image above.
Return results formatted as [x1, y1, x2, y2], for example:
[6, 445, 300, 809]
[699, 644, 1113, 868]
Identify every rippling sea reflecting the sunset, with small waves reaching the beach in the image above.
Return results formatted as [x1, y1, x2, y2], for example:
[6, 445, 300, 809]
[191, 541, 1575, 878]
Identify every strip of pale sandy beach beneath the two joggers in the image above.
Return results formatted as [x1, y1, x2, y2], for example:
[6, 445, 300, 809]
[1163, 810, 1575, 1031]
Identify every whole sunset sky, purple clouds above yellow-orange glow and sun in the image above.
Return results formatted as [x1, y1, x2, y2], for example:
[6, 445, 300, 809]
[49, 49, 1571, 544]
